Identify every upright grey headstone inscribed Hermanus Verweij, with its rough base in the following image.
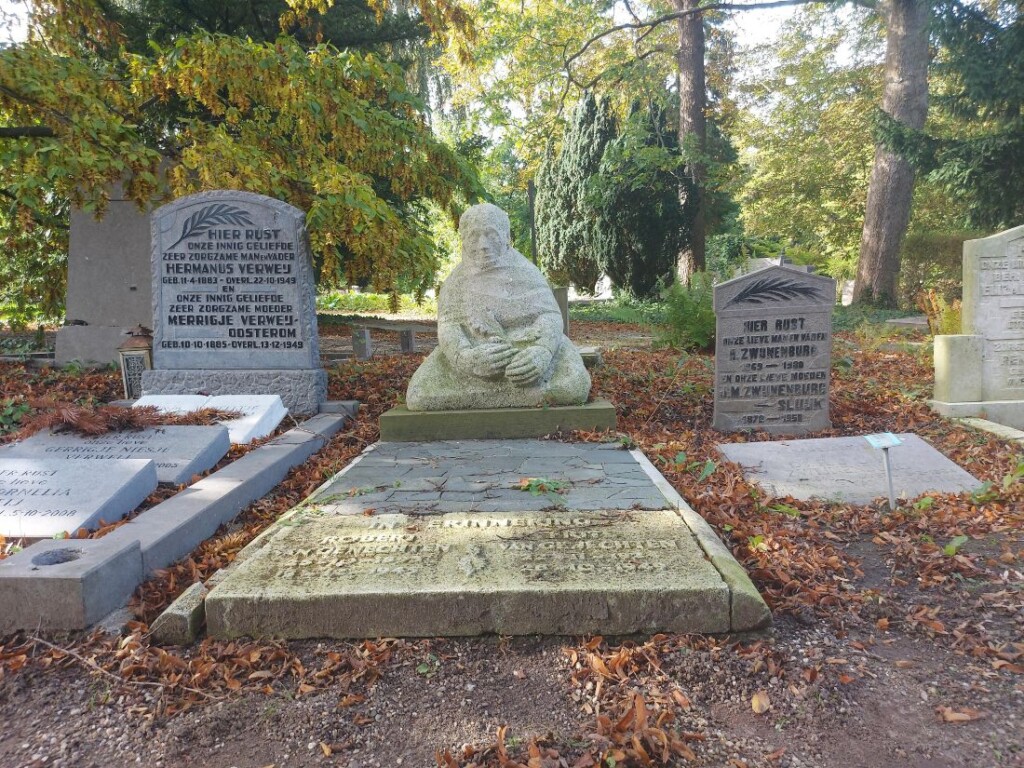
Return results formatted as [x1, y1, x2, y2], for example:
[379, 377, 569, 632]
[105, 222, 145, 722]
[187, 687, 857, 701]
[142, 190, 327, 415]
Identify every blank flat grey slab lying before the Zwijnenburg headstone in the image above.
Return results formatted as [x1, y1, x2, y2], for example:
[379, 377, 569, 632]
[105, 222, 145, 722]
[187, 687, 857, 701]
[718, 433, 981, 504]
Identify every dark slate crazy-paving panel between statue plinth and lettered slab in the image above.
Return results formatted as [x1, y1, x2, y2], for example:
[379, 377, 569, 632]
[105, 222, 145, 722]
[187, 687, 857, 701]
[311, 440, 666, 514]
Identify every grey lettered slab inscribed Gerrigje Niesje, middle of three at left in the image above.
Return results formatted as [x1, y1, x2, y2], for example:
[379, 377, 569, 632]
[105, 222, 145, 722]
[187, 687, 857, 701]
[0, 426, 231, 484]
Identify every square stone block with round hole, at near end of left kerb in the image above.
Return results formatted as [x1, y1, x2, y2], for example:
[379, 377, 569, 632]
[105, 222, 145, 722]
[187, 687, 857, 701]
[0, 537, 142, 635]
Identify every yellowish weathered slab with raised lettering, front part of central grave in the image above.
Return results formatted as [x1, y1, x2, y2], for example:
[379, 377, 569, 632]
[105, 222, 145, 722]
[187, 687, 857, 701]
[206, 510, 730, 638]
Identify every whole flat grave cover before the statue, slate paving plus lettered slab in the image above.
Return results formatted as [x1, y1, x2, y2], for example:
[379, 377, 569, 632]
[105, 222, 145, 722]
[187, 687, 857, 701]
[206, 440, 770, 638]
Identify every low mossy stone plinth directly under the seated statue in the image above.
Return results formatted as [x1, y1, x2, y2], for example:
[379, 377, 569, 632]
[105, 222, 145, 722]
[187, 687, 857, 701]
[381, 399, 615, 441]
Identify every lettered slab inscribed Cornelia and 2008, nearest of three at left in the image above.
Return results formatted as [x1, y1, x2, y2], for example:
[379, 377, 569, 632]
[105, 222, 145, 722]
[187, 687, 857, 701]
[0, 458, 157, 539]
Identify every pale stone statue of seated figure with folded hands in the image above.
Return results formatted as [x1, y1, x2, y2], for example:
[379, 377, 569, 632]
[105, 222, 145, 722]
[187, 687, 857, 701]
[406, 203, 590, 411]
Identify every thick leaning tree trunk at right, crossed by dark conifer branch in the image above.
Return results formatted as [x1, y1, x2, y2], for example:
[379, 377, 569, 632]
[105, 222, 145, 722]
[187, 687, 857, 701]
[853, 0, 929, 306]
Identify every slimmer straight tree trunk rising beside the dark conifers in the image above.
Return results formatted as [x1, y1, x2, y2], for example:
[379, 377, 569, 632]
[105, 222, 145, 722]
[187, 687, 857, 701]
[674, 0, 708, 283]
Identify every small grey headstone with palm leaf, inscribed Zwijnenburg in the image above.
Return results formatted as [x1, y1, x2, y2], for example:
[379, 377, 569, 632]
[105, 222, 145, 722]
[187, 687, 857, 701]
[714, 266, 836, 434]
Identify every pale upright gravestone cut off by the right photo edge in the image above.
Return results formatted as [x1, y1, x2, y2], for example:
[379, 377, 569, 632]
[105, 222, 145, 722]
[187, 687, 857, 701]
[932, 226, 1024, 429]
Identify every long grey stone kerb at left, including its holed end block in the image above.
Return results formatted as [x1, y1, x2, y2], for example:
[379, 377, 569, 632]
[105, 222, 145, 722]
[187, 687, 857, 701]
[0, 402, 357, 635]
